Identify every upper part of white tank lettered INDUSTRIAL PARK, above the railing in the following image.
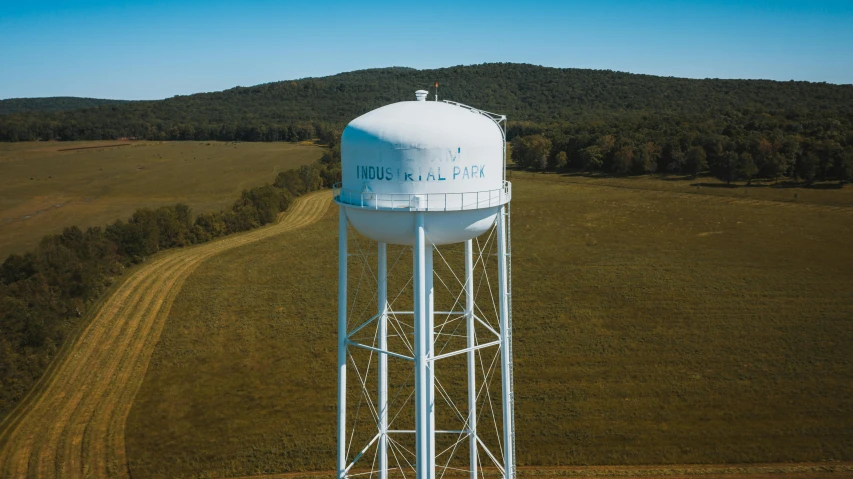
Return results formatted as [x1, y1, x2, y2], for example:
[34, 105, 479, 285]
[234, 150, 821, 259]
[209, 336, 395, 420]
[341, 101, 504, 199]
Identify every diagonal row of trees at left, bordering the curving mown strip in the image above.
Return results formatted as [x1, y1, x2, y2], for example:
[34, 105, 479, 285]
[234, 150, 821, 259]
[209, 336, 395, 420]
[0, 162, 340, 418]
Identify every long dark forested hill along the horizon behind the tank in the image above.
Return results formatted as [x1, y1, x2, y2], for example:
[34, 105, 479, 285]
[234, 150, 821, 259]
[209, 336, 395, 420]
[0, 63, 853, 141]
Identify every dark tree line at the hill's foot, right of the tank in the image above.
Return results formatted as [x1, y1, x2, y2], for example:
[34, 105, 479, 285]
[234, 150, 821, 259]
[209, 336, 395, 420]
[507, 112, 853, 184]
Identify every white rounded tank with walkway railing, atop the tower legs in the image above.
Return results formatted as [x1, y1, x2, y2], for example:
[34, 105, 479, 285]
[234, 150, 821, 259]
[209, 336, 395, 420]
[336, 91, 510, 245]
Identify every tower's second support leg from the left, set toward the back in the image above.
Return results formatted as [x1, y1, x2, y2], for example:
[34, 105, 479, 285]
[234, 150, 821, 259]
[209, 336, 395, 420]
[376, 243, 388, 479]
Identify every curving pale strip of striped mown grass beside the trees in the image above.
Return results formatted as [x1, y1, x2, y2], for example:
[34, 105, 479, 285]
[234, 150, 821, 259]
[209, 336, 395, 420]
[0, 191, 331, 478]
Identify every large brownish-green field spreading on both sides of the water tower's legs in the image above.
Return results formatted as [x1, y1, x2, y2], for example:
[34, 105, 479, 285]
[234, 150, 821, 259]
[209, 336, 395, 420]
[126, 174, 853, 478]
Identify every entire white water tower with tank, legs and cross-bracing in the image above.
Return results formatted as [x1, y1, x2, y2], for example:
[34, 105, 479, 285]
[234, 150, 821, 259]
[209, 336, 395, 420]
[334, 90, 515, 479]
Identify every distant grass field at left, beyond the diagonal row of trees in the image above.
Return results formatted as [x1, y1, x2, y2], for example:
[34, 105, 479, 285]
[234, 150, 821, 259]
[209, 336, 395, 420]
[0, 141, 322, 260]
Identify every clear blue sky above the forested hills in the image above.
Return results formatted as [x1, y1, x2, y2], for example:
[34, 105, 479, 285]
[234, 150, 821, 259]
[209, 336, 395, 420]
[0, 0, 853, 99]
